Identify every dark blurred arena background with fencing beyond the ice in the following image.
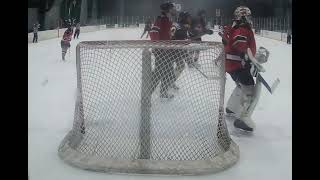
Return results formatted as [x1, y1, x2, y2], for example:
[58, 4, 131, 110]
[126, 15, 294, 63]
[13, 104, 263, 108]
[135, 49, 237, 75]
[28, 0, 292, 33]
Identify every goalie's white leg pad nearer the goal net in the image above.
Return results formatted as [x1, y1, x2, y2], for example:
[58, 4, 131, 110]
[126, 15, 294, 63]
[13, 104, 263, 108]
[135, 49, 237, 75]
[226, 85, 242, 118]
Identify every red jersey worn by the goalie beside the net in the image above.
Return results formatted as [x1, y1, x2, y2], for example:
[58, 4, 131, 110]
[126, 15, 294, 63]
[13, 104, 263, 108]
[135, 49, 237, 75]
[223, 26, 256, 72]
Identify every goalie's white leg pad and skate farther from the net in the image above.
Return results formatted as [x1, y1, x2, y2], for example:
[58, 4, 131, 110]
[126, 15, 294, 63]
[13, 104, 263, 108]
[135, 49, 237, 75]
[234, 81, 261, 132]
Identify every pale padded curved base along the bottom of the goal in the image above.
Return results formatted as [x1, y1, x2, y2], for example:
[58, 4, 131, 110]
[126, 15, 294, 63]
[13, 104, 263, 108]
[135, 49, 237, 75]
[59, 137, 240, 175]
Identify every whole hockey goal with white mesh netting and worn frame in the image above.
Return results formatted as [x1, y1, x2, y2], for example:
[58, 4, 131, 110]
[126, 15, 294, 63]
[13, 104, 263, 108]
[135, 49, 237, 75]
[58, 41, 239, 175]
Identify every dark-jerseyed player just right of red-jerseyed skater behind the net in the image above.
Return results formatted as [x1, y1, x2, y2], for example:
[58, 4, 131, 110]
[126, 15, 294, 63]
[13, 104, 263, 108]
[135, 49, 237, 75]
[170, 11, 192, 90]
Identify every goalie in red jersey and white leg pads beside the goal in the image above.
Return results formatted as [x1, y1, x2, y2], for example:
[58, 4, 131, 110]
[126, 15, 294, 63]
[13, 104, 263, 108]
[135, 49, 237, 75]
[220, 6, 260, 132]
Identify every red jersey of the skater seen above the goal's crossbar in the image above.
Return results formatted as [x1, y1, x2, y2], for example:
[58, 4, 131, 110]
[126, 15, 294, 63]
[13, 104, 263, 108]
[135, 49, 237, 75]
[149, 14, 172, 40]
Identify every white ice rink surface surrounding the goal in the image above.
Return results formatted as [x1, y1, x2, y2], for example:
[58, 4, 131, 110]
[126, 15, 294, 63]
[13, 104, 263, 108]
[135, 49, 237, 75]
[28, 28, 292, 180]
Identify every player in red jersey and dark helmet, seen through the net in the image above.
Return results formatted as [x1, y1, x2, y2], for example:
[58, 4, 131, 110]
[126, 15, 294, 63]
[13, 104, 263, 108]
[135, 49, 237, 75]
[149, 2, 176, 99]
